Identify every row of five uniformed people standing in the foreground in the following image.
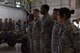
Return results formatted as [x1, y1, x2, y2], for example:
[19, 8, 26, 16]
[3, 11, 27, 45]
[22, 4, 80, 53]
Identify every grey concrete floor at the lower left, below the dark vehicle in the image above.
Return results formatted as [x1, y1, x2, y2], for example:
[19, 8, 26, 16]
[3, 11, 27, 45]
[0, 43, 21, 53]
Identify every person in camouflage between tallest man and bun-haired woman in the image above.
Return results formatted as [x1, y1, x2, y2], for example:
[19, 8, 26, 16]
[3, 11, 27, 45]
[51, 8, 60, 53]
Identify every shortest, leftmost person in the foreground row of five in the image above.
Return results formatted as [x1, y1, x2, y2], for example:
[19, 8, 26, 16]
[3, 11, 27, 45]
[28, 14, 34, 53]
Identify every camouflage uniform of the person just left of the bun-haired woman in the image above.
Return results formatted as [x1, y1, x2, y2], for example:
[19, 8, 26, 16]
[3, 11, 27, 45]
[51, 22, 60, 53]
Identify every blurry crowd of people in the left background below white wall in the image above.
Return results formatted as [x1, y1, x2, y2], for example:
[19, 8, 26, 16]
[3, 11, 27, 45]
[0, 18, 27, 32]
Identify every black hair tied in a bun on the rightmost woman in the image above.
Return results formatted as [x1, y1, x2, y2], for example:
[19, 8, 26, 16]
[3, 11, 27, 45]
[59, 7, 75, 19]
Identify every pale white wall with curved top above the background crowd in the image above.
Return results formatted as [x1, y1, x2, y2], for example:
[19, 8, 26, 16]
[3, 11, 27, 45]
[0, 6, 26, 21]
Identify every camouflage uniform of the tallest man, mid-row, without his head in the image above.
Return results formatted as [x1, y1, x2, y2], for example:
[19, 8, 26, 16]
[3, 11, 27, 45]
[40, 14, 53, 53]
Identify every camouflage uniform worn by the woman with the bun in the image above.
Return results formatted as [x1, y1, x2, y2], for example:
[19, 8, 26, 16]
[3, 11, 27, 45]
[58, 22, 80, 53]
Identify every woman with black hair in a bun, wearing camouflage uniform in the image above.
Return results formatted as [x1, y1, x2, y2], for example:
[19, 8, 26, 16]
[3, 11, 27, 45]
[58, 7, 80, 53]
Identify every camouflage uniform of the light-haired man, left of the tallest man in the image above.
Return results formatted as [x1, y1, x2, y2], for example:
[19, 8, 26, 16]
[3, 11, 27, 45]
[32, 18, 41, 53]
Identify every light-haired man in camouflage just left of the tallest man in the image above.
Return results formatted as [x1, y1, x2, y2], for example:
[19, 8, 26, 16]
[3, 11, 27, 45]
[32, 9, 41, 53]
